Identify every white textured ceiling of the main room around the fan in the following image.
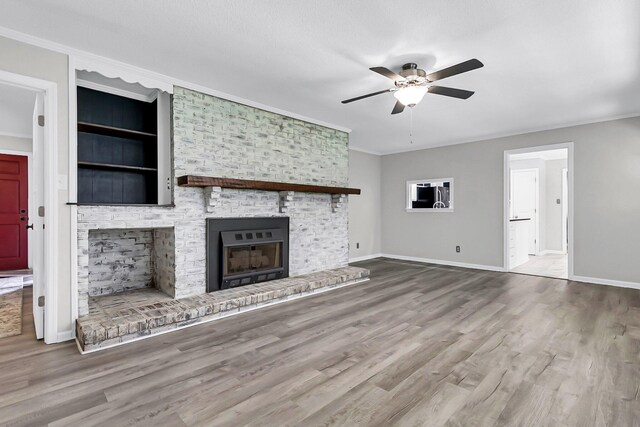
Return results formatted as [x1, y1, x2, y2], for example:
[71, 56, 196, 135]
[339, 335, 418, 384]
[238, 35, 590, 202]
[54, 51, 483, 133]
[0, 0, 640, 153]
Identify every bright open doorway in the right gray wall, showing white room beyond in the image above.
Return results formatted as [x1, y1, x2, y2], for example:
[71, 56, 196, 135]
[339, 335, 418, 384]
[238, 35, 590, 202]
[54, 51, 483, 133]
[504, 144, 573, 279]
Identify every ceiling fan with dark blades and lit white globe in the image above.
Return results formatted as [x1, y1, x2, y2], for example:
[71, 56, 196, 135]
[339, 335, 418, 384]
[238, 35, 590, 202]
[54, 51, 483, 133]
[342, 58, 484, 114]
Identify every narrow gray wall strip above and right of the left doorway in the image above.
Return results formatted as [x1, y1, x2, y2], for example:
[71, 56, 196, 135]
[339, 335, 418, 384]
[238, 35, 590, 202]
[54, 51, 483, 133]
[0, 37, 75, 340]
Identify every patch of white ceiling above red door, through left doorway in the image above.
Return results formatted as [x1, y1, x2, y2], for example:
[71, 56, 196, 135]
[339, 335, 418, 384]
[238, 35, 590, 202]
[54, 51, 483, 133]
[0, 84, 36, 138]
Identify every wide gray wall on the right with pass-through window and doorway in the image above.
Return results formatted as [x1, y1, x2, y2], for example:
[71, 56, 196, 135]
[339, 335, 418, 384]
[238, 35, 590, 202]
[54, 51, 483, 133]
[382, 117, 640, 282]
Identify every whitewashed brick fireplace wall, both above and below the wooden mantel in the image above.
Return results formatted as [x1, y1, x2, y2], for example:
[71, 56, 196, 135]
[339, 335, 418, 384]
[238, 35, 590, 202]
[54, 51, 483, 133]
[78, 87, 356, 315]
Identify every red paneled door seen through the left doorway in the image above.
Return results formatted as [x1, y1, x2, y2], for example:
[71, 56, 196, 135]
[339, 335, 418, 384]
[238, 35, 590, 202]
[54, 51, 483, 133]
[0, 154, 29, 271]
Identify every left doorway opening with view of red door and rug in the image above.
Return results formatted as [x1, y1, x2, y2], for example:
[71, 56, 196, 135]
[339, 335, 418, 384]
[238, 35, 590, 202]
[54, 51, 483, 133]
[0, 71, 58, 343]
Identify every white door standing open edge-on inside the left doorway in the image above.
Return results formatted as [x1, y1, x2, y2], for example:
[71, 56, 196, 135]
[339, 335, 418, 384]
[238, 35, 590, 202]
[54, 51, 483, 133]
[29, 93, 46, 339]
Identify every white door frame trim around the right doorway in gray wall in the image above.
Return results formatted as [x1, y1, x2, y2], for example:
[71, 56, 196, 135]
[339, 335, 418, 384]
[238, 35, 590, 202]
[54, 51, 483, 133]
[502, 142, 575, 280]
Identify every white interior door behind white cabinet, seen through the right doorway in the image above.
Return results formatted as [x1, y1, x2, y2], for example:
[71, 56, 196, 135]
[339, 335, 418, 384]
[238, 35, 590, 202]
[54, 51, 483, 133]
[511, 169, 539, 255]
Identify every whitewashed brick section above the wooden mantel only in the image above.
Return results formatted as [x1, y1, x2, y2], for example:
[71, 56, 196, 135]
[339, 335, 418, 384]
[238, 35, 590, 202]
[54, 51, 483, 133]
[173, 87, 349, 186]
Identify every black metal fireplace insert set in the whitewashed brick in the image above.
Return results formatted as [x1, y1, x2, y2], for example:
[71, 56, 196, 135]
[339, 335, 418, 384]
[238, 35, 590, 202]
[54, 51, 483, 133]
[207, 217, 289, 292]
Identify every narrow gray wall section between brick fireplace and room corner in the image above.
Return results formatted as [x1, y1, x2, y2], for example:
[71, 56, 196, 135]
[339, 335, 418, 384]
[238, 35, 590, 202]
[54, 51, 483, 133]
[349, 150, 382, 259]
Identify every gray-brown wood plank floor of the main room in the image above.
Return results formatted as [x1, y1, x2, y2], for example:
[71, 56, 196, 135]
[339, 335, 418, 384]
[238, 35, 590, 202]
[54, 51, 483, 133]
[0, 260, 640, 426]
